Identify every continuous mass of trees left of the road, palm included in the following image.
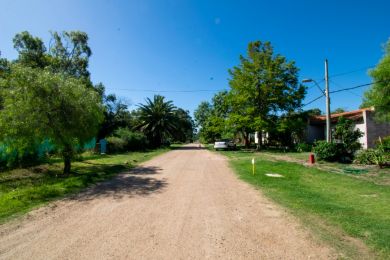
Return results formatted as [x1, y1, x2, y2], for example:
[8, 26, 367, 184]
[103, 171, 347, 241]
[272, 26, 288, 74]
[0, 31, 194, 173]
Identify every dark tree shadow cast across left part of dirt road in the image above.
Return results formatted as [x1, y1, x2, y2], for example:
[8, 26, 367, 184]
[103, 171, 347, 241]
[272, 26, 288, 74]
[71, 166, 167, 201]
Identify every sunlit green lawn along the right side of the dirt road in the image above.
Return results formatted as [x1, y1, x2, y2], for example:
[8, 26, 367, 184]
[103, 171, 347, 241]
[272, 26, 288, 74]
[223, 151, 390, 258]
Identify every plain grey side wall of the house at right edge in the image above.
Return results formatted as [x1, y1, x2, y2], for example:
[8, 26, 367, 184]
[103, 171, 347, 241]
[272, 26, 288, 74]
[365, 111, 390, 148]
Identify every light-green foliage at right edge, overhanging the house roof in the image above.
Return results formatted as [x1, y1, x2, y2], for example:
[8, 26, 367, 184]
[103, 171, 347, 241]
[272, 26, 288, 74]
[362, 39, 390, 122]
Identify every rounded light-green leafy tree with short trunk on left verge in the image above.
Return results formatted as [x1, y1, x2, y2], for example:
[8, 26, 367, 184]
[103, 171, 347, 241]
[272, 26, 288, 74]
[0, 64, 103, 174]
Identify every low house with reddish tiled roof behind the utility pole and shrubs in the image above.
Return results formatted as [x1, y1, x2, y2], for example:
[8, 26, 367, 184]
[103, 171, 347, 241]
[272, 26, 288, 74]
[306, 108, 390, 149]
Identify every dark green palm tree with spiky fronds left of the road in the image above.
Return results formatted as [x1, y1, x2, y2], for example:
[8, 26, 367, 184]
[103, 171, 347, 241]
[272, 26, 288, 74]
[136, 95, 177, 147]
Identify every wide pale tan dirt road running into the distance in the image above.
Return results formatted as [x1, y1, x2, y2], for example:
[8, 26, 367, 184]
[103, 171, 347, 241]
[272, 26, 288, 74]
[0, 146, 334, 259]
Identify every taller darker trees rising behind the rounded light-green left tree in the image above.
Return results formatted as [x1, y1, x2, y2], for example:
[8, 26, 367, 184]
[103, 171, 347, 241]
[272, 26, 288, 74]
[12, 31, 123, 143]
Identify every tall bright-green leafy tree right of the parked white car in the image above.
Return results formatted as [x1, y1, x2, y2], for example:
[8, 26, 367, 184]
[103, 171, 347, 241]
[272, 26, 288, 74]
[229, 41, 306, 148]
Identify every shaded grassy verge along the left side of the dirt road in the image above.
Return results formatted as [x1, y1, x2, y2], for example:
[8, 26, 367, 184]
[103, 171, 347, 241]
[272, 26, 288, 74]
[0, 148, 170, 224]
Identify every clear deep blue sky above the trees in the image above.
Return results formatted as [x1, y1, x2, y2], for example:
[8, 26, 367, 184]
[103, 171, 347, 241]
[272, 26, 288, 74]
[0, 0, 390, 116]
